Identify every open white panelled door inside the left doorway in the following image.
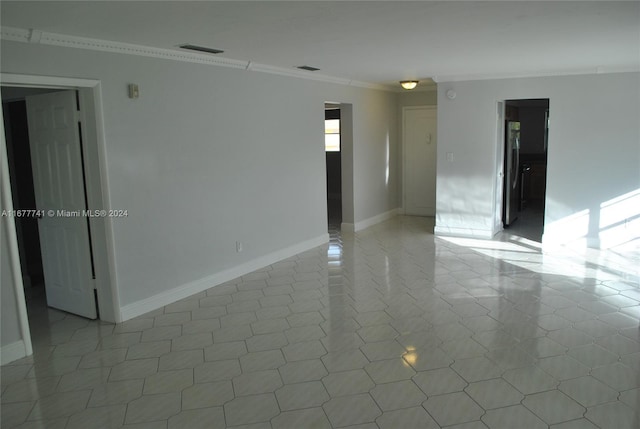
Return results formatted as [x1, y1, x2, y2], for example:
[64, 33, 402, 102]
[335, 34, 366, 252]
[26, 91, 96, 319]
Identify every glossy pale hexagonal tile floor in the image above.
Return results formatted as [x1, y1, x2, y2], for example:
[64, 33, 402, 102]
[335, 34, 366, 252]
[1, 216, 640, 429]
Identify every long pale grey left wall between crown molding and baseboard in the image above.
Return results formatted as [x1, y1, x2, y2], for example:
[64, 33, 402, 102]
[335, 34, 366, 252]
[1, 41, 397, 317]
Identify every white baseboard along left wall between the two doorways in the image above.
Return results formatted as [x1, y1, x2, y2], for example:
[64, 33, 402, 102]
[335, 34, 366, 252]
[120, 234, 329, 322]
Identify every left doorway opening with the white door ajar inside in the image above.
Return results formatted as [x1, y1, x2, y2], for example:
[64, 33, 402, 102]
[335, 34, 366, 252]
[2, 87, 99, 324]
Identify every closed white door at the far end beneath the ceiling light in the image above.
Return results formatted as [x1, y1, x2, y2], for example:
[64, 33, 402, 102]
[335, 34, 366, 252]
[403, 107, 437, 216]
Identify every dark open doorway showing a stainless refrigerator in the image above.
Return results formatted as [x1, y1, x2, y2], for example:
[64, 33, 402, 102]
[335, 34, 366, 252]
[502, 99, 549, 242]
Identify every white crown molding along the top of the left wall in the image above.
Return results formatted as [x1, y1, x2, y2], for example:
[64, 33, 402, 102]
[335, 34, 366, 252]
[0, 27, 392, 91]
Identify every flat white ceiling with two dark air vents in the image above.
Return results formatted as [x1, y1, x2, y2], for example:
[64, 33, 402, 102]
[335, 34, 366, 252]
[0, 0, 640, 88]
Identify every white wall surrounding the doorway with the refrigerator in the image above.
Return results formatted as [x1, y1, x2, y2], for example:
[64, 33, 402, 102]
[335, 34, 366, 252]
[436, 73, 640, 247]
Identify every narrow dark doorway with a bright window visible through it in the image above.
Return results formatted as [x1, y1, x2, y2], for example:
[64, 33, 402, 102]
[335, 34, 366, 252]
[324, 103, 342, 231]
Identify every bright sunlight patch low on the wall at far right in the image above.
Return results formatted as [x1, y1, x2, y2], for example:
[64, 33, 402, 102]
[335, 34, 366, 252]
[544, 189, 640, 249]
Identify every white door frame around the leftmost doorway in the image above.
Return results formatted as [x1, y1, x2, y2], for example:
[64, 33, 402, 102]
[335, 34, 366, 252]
[0, 73, 122, 355]
